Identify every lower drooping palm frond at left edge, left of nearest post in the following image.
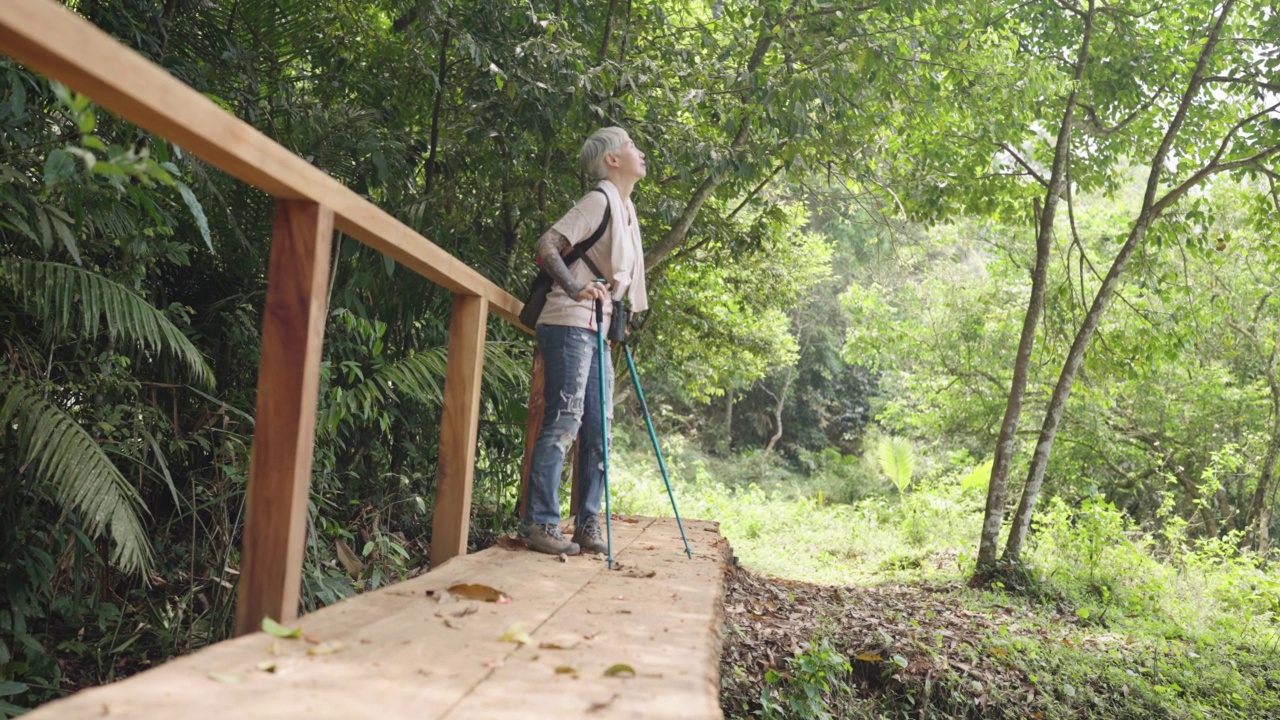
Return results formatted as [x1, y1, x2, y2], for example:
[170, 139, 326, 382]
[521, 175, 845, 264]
[0, 378, 155, 573]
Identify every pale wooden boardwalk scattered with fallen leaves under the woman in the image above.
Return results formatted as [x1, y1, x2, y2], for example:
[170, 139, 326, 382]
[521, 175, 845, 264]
[26, 518, 728, 720]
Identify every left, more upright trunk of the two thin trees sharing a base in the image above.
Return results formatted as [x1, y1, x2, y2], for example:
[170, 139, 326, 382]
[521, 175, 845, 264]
[974, 3, 1093, 571]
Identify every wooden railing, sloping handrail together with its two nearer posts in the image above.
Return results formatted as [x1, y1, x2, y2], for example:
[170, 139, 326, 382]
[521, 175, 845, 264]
[0, 0, 521, 634]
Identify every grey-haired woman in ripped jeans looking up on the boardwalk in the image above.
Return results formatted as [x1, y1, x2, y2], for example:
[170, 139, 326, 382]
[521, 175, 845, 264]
[520, 127, 649, 555]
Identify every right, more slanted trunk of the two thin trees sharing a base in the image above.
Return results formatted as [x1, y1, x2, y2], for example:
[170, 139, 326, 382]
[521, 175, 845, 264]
[1005, 0, 1235, 561]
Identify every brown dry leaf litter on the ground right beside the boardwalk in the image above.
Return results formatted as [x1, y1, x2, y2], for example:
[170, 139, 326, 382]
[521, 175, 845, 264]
[721, 566, 1100, 716]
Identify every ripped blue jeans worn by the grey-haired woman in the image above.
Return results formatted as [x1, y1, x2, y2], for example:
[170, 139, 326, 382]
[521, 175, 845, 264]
[522, 325, 613, 525]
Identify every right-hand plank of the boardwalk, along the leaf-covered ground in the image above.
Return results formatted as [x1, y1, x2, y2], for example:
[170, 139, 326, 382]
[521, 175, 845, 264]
[445, 520, 728, 720]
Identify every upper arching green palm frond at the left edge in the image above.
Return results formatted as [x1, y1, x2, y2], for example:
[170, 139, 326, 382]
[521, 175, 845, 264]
[0, 258, 214, 388]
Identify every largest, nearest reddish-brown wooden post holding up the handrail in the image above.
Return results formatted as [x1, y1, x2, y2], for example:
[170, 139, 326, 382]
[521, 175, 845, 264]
[236, 200, 333, 635]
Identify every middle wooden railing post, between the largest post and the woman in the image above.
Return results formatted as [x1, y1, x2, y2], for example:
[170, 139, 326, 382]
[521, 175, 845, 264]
[431, 293, 489, 568]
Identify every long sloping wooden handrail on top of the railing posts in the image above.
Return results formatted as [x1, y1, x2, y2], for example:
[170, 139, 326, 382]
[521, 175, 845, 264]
[0, 0, 526, 329]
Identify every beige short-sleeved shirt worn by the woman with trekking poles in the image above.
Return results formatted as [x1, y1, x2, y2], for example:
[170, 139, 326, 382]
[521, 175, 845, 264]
[538, 185, 644, 333]
